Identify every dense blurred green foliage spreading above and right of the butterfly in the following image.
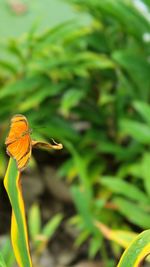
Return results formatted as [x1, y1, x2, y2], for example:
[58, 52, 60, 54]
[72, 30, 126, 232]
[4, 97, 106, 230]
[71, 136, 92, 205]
[0, 0, 150, 260]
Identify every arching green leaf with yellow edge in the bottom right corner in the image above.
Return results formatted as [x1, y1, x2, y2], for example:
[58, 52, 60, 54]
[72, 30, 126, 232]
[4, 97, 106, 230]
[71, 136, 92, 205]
[117, 230, 150, 267]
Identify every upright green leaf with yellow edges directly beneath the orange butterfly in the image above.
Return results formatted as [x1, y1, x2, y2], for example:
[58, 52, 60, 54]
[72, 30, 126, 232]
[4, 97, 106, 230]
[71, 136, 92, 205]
[4, 158, 32, 267]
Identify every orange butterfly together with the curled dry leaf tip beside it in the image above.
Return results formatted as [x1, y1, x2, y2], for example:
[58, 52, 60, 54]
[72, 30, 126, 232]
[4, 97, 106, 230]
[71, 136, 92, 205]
[5, 114, 63, 171]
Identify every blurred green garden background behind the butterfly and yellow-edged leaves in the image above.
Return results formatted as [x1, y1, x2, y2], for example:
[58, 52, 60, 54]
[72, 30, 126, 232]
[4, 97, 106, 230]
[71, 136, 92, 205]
[0, 0, 150, 267]
